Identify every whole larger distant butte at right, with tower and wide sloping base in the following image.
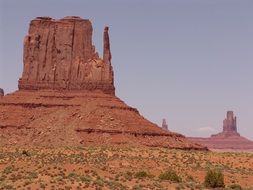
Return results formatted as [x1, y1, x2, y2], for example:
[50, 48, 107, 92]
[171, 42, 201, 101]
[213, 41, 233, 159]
[189, 111, 253, 151]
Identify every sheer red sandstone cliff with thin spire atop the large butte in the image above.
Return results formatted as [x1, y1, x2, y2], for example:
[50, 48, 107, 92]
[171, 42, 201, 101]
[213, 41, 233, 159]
[19, 17, 115, 94]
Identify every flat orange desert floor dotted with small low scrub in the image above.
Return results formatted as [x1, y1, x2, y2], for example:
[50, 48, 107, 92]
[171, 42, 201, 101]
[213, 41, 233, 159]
[0, 146, 253, 190]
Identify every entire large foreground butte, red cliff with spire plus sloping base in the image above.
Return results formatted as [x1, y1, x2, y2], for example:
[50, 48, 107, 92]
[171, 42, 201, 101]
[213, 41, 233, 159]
[0, 16, 207, 150]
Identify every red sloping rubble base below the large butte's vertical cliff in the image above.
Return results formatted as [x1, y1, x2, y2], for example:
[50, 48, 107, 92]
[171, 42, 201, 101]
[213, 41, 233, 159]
[0, 90, 206, 150]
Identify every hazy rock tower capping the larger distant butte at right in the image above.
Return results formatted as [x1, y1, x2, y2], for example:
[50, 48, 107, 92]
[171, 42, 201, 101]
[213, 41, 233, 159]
[211, 111, 240, 137]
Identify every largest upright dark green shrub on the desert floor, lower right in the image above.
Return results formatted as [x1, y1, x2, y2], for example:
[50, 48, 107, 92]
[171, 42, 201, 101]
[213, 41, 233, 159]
[204, 170, 225, 188]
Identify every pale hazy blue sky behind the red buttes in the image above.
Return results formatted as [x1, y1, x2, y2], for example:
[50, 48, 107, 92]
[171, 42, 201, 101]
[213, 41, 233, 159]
[0, 0, 253, 139]
